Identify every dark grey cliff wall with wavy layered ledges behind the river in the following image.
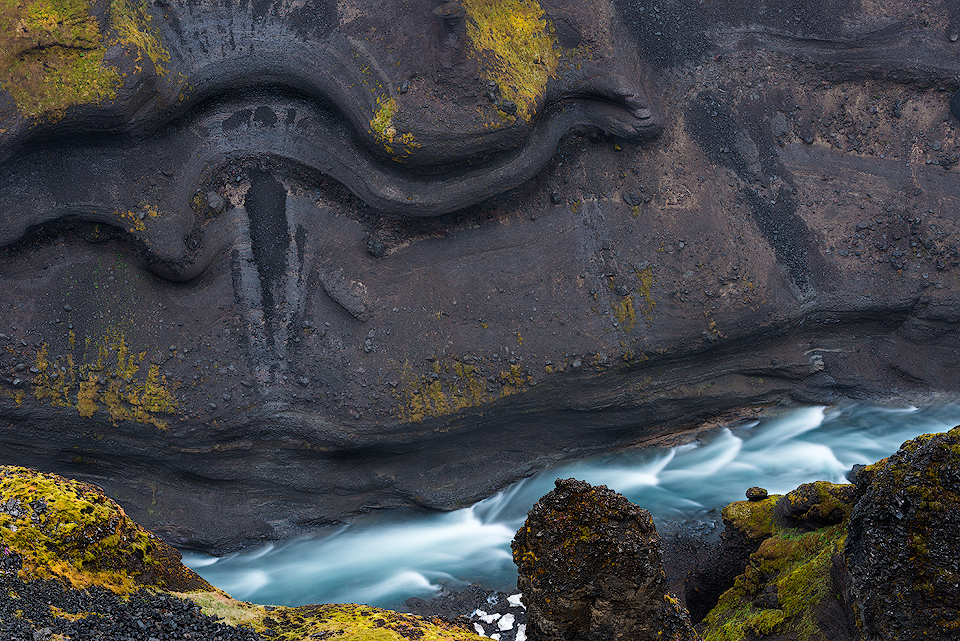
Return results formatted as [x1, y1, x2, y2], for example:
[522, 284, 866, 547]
[0, 0, 960, 550]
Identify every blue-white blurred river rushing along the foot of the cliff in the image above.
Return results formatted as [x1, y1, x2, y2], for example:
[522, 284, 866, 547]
[183, 404, 960, 608]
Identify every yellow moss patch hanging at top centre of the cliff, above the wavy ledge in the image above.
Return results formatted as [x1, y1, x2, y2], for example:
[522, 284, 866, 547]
[462, 0, 559, 122]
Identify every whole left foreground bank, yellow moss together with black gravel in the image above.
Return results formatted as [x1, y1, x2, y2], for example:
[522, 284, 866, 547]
[0, 467, 479, 641]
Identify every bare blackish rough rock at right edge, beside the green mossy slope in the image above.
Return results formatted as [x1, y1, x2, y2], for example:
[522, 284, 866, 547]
[845, 428, 960, 641]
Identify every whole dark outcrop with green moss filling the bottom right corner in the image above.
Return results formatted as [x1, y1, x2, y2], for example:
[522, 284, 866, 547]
[687, 427, 960, 641]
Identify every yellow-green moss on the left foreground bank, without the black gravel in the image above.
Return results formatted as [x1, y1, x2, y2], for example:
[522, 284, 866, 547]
[0, 466, 480, 641]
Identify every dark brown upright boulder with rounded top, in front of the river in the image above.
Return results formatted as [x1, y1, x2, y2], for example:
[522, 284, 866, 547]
[512, 479, 696, 641]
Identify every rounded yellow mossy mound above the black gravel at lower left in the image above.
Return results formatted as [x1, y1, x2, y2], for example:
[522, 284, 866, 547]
[0, 466, 211, 593]
